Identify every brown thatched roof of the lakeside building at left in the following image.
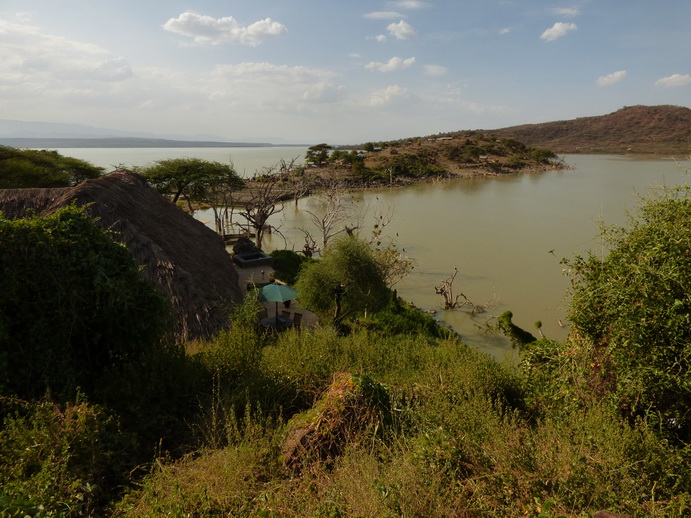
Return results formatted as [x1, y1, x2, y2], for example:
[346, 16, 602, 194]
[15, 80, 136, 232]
[0, 171, 242, 339]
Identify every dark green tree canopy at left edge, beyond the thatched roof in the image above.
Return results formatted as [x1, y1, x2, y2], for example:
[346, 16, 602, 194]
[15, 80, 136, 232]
[0, 146, 104, 189]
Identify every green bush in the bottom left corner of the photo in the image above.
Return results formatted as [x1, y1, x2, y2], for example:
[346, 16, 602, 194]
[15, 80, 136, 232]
[0, 399, 134, 517]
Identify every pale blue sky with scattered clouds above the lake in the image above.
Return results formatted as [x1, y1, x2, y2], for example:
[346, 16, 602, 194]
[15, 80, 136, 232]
[0, 0, 691, 144]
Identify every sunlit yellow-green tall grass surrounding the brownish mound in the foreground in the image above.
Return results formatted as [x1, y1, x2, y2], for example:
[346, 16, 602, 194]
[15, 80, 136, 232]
[111, 318, 691, 517]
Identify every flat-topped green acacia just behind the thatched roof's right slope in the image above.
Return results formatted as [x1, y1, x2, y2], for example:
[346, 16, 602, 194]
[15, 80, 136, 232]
[140, 158, 244, 212]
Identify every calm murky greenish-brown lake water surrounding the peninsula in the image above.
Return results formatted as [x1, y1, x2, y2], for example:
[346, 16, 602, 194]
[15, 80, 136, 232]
[54, 147, 689, 358]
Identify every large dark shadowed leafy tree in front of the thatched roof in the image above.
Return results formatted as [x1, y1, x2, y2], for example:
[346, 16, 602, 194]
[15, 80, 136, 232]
[0, 207, 168, 397]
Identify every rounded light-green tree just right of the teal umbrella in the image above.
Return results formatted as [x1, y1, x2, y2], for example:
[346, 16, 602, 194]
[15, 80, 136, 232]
[295, 236, 391, 324]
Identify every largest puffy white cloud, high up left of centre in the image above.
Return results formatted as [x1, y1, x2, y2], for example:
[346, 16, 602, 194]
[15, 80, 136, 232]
[163, 11, 288, 47]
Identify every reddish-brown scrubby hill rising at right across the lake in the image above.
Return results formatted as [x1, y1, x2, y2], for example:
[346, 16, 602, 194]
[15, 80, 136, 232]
[485, 106, 691, 156]
